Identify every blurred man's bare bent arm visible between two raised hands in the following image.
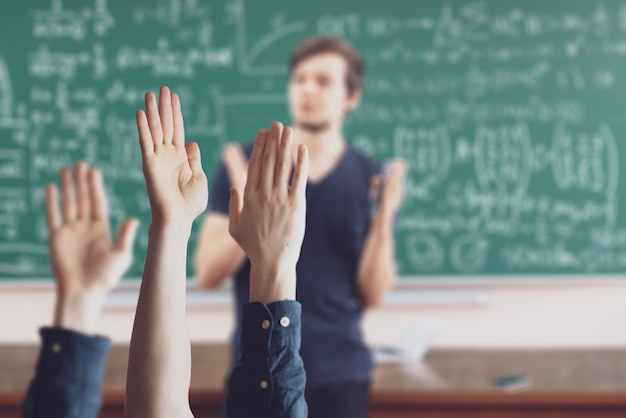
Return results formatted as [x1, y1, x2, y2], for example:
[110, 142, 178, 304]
[193, 212, 246, 289]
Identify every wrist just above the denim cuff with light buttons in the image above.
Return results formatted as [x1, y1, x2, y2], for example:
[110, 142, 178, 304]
[250, 261, 296, 305]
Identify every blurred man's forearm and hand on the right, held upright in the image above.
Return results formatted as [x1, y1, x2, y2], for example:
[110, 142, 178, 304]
[357, 161, 406, 308]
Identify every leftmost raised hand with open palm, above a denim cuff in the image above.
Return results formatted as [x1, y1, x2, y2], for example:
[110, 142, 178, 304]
[46, 162, 139, 332]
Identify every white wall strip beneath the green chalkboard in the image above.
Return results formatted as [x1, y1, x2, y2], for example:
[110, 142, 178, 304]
[0, 282, 626, 348]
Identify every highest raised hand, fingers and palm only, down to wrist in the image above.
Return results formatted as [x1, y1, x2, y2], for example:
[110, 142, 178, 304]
[136, 87, 209, 226]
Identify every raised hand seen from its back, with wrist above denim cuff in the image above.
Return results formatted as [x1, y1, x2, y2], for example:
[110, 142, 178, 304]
[229, 122, 309, 303]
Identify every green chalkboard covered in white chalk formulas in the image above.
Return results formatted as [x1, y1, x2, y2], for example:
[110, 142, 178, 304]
[0, 0, 626, 280]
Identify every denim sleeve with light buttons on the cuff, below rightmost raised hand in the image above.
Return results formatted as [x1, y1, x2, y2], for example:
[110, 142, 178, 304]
[226, 301, 308, 418]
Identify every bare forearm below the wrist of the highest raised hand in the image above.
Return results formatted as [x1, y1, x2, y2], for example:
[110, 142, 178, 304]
[126, 223, 191, 417]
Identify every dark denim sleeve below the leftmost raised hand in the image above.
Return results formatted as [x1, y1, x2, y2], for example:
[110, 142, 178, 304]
[23, 328, 111, 418]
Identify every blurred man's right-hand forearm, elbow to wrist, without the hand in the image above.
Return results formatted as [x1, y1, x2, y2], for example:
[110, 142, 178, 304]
[358, 220, 397, 307]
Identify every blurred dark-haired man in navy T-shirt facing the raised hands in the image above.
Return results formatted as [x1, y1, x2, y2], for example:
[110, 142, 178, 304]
[194, 37, 405, 418]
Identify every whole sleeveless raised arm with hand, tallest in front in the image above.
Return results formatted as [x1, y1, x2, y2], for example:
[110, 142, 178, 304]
[125, 87, 208, 418]
